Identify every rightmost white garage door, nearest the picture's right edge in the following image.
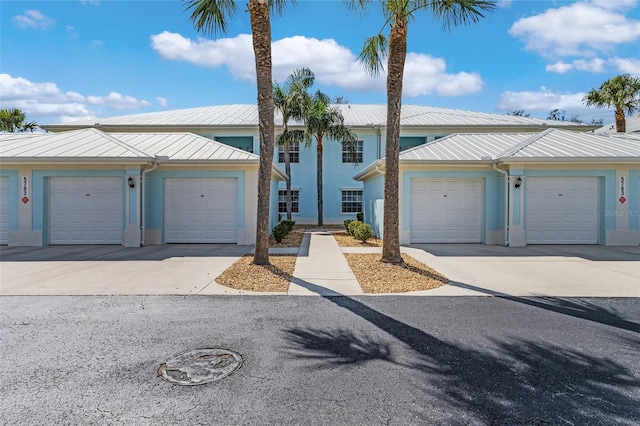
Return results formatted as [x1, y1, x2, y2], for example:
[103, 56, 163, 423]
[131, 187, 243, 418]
[525, 177, 599, 244]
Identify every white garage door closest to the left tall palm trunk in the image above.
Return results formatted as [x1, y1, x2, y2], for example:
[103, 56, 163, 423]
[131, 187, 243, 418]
[165, 178, 238, 243]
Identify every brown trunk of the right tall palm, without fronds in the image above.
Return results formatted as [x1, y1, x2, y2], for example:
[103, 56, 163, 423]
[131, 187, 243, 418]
[382, 20, 407, 264]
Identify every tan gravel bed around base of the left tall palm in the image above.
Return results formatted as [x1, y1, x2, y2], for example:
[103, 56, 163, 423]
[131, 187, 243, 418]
[216, 254, 296, 293]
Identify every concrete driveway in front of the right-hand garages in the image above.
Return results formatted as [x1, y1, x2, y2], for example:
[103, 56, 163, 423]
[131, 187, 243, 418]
[403, 244, 640, 297]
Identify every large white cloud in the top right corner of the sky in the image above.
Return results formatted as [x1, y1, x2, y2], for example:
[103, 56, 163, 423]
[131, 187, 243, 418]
[509, 0, 640, 57]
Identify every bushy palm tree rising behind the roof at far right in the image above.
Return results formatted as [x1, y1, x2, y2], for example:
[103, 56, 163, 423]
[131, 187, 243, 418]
[582, 74, 640, 133]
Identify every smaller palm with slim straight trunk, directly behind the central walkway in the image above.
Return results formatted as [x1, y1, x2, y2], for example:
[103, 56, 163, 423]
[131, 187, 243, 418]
[304, 90, 358, 226]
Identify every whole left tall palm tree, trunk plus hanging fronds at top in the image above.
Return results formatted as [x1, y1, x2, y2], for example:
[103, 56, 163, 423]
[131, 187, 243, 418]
[183, 0, 295, 265]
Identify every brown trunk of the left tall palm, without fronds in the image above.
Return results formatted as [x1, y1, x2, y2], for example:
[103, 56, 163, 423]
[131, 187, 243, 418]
[249, 0, 274, 265]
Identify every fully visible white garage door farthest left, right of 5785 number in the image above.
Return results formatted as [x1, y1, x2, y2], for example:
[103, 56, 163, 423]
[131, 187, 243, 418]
[49, 177, 124, 244]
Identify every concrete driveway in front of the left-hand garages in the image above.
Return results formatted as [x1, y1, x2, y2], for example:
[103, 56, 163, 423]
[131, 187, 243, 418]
[0, 244, 252, 295]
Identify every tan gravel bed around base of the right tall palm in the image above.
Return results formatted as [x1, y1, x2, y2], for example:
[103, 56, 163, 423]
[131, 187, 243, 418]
[344, 253, 449, 293]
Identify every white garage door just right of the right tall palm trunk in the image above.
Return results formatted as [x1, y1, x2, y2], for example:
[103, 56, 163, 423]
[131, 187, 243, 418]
[411, 179, 482, 243]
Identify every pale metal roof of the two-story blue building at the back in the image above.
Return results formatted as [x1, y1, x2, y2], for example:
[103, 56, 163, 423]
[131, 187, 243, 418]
[42, 104, 592, 130]
